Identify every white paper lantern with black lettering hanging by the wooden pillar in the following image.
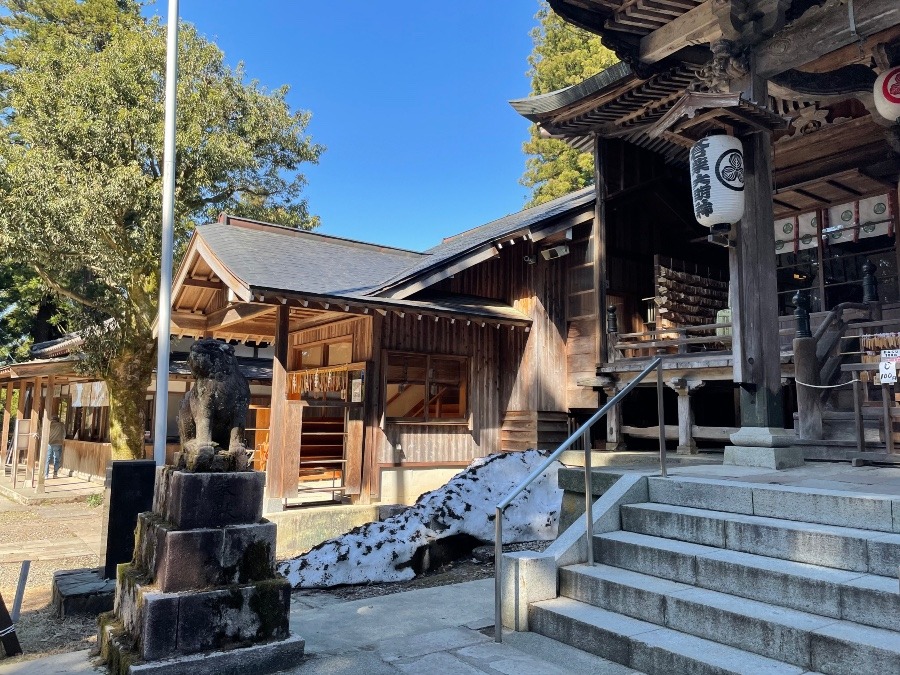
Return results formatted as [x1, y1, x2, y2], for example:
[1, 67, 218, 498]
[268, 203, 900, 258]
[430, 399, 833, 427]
[691, 136, 744, 227]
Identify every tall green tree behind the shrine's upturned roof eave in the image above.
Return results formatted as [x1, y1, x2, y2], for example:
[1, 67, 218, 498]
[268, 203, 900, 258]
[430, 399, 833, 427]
[520, 2, 617, 206]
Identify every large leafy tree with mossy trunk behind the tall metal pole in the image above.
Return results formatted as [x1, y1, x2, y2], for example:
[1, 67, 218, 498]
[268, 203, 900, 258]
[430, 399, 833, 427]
[0, 0, 322, 458]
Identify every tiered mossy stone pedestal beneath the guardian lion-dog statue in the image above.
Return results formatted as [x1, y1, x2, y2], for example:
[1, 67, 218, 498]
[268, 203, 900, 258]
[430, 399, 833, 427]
[99, 467, 303, 675]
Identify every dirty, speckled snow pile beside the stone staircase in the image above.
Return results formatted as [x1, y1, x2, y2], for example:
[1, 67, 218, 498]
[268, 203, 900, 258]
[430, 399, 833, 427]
[278, 450, 562, 588]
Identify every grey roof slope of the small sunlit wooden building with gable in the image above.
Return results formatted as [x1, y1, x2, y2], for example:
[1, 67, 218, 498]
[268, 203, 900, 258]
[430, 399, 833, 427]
[197, 223, 423, 296]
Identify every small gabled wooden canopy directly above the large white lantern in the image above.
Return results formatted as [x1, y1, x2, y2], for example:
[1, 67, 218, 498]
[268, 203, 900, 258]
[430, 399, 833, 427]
[646, 92, 790, 144]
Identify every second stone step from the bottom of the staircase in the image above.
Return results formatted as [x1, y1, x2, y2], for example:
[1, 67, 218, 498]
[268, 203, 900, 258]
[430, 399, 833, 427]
[560, 565, 900, 673]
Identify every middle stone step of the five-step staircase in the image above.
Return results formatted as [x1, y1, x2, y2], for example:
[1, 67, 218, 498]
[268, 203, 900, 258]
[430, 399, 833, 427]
[594, 531, 900, 630]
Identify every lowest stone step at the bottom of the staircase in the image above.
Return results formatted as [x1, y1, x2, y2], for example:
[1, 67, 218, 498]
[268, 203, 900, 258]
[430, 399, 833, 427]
[528, 598, 808, 675]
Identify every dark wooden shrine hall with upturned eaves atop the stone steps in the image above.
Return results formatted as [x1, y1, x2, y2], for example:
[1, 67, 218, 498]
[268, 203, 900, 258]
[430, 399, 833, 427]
[511, 0, 900, 456]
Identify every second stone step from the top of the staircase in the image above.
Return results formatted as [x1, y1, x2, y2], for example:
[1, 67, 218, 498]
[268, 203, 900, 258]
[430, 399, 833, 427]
[621, 504, 900, 576]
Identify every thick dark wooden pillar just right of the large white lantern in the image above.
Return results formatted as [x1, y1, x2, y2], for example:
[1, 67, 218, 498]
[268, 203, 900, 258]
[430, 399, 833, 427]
[729, 92, 784, 428]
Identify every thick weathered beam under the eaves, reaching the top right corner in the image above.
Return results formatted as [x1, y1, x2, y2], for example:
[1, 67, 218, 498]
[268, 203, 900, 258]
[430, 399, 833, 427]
[755, 0, 900, 78]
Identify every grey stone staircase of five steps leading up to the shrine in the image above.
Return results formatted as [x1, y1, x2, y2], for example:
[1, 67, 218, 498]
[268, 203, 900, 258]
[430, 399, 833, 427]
[528, 478, 900, 675]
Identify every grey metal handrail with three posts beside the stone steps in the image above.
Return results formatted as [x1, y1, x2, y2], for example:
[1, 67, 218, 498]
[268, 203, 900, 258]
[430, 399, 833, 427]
[494, 356, 668, 642]
